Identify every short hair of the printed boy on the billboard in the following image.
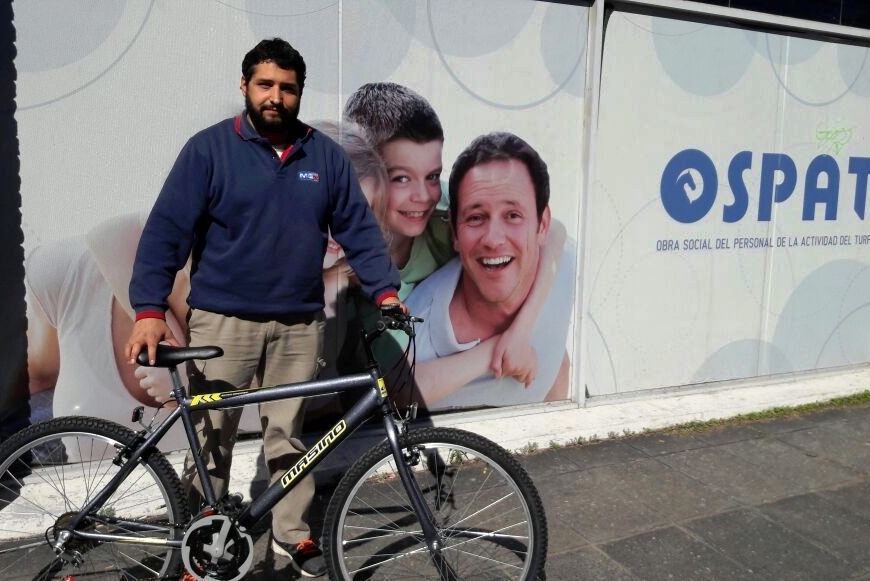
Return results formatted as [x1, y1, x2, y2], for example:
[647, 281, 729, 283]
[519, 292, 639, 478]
[344, 83, 444, 150]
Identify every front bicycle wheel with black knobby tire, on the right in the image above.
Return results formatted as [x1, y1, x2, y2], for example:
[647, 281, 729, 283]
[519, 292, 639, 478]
[323, 428, 547, 580]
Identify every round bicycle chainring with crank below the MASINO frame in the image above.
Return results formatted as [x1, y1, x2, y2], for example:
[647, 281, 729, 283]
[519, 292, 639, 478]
[181, 514, 254, 581]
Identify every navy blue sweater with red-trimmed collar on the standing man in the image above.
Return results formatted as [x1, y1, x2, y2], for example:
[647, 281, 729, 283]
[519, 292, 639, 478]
[130, 114, 400, 317]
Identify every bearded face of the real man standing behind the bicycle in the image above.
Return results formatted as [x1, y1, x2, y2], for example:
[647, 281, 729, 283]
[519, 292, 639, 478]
[241, 61, 302, 134]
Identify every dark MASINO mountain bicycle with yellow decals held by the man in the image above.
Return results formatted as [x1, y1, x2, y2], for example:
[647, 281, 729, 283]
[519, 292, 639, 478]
[0, 311, 547, 581]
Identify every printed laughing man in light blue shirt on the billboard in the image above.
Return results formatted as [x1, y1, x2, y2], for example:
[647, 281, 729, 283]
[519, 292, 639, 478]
[407, 133, 576, 411]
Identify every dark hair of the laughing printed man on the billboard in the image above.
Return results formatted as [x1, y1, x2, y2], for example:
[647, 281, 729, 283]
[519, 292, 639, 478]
[449, 132, 550, 231]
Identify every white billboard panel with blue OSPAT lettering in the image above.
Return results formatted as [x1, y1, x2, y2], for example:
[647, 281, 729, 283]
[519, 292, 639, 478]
[583, 11, 870, 396]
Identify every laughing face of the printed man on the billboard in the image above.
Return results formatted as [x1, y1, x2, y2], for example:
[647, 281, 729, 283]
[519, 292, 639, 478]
[454, 159, 550, 314]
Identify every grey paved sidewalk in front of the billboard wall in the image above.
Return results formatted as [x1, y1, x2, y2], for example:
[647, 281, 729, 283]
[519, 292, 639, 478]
[235, 398, 870, 581]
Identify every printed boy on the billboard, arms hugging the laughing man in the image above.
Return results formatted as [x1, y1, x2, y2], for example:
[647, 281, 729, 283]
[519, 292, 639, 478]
[338, 87, 567, 409]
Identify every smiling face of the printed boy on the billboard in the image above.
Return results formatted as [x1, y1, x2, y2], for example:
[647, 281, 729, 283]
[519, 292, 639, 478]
[381, 139, 443, 238]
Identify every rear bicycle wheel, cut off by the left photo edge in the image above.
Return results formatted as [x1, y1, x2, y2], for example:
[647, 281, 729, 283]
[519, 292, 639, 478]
[0, 416, 190, 580]
